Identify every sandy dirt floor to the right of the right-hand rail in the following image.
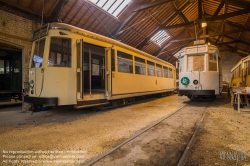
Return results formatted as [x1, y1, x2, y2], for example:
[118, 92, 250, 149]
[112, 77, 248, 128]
[186, 101, 250, 166]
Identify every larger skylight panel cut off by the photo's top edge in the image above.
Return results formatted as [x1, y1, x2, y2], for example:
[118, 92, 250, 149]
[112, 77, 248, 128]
[90, 0, 131, 17]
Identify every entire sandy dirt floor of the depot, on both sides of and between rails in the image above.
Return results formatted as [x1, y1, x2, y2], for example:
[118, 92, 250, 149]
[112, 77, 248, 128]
[0, 95, 250, 165]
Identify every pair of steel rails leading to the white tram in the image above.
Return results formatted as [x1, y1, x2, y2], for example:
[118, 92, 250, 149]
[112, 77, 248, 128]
[83, 101, 211, 166]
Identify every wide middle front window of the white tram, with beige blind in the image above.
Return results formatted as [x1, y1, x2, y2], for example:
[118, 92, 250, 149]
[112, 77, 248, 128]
[187, 55, 204, 72]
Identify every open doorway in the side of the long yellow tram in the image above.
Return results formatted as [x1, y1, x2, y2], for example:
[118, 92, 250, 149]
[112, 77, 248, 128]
[82, 43, 105, 98]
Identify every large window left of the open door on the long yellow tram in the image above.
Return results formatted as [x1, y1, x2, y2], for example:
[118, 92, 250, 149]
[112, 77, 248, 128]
[49, 37, 71, 67]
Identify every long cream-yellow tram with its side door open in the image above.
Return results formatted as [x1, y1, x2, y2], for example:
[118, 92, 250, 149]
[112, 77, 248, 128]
[24, 23, 176, 108]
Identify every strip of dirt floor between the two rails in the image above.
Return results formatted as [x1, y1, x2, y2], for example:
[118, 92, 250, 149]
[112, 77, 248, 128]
[89, 102, 209, 166]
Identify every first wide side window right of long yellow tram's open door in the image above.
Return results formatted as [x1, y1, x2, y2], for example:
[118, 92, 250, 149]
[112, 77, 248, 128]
[117, 51, 133, 73]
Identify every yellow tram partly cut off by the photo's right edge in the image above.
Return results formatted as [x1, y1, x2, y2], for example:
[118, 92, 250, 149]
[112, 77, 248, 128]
[231, 55, 250, 86]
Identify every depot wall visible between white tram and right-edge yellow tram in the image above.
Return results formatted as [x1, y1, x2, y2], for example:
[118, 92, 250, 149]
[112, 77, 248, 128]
[220, 51, 242, 82]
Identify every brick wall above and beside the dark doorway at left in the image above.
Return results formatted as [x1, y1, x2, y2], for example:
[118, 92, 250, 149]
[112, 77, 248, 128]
[0, 6, 39, 85]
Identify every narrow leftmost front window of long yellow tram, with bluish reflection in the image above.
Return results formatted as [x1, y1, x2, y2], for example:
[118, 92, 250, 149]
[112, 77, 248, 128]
[31, 39, 45, 68]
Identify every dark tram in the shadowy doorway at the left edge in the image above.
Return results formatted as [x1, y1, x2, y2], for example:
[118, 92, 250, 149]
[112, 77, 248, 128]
[0, 50, 22, 102]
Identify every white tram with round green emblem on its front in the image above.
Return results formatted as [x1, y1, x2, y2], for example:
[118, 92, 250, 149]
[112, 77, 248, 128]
[175, 44, 222, 99]
